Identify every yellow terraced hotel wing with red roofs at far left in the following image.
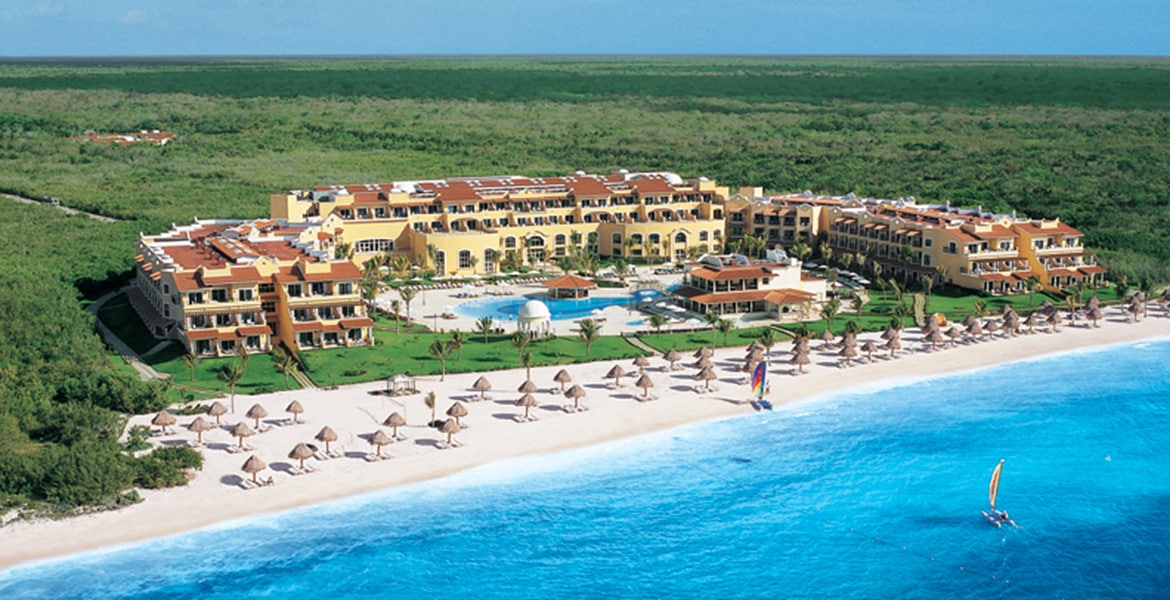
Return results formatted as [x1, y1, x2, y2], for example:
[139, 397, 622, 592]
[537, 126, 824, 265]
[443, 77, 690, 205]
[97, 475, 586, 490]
[129, 219, 373, 357]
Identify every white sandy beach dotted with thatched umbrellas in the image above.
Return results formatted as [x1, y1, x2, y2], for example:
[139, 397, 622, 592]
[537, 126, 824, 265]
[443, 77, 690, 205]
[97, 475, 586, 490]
[0, 303, 1170, 567]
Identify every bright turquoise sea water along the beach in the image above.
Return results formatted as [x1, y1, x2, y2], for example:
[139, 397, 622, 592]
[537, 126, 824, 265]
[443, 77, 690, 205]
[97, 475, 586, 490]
[0, 336, 1170, 600]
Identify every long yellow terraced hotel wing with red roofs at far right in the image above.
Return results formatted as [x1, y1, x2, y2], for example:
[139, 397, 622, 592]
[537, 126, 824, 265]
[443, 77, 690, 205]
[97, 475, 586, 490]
[827, 195, 1106, 294]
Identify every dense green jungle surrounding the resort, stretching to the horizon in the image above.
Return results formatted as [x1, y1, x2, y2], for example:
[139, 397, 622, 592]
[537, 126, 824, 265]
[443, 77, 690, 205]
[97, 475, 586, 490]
[0, 57, 1170, 506]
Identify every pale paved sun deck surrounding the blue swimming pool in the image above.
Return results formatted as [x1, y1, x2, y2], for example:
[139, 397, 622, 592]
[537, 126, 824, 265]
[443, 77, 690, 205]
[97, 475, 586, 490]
[376, 274, 706, 336]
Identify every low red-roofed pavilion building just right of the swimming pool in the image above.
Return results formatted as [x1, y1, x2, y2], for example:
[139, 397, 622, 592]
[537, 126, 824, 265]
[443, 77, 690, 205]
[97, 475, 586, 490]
[672, 249, 827, 319]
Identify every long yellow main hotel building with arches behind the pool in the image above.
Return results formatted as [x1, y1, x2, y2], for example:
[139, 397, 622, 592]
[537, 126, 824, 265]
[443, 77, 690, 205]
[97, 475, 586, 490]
[269, 170, 728, 275]
